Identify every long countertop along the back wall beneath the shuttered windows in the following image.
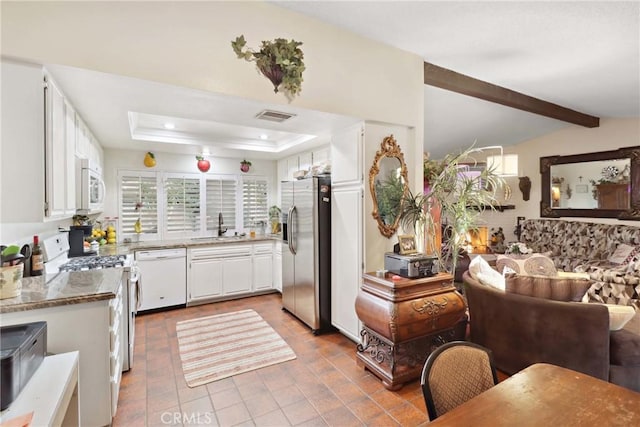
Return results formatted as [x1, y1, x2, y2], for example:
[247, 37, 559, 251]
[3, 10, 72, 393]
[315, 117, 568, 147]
[98, 234, 282, 255]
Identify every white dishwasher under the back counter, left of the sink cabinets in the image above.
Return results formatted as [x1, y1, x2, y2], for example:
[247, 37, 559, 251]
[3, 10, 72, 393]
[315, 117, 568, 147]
[136, 248, 187, 312]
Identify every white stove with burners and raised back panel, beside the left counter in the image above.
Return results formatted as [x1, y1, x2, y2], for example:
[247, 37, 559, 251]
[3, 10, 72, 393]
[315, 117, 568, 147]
[42, 233, 141, 371]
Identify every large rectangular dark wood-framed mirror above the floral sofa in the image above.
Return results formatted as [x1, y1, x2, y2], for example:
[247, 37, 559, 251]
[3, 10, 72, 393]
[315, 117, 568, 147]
[540, 146, 640, 221]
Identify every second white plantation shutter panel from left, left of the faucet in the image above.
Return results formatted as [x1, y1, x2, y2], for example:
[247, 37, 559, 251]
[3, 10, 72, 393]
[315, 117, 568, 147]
[164, 174, 200, 237]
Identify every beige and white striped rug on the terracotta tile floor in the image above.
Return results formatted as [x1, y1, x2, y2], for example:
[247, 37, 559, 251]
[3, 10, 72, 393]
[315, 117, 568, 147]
[176, 310, 296, 387]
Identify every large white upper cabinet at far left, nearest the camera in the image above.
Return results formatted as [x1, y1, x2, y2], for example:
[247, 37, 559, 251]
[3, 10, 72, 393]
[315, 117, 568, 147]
[0, 60, 102, 223]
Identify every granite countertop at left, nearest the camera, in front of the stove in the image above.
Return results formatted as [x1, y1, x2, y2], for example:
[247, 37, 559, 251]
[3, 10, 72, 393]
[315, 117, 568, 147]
[0, 268, 122, 314]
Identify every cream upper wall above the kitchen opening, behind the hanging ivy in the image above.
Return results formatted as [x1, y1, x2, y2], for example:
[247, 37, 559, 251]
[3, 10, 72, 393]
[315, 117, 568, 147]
[1, 1, 424, 132]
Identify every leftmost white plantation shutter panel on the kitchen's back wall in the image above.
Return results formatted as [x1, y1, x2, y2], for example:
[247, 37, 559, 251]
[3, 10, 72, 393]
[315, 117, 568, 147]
[119, 172, 158, 236]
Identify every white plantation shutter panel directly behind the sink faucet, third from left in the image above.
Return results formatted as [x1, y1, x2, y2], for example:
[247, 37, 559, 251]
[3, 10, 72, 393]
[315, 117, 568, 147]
[206, 177, 237, 232]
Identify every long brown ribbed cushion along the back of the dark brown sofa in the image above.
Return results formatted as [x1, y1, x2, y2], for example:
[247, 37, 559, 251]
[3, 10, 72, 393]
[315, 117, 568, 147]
[505, 274, 591, 302]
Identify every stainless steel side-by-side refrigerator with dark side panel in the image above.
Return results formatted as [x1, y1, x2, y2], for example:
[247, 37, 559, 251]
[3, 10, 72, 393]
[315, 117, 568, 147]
[282, 176, 334, 334]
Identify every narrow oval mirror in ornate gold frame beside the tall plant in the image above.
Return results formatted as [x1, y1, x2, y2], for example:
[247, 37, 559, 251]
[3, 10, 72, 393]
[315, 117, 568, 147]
[369, 135, 409, 238]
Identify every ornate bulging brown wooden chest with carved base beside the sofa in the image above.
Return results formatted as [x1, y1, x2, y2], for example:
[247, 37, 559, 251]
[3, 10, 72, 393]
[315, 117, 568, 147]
[356, 273, 467, 390]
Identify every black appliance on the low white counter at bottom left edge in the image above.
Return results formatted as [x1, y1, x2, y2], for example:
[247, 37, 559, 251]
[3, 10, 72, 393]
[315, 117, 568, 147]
[0, 322, 47, 411]
